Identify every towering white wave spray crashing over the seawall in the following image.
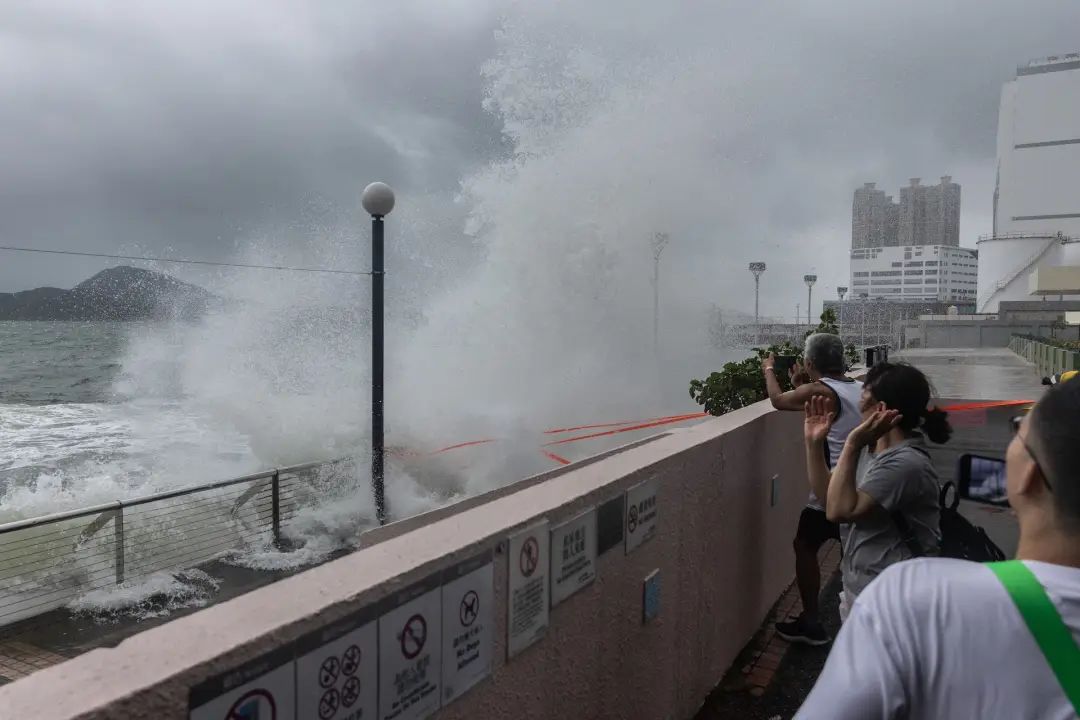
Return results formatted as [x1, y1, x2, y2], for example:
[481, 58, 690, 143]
[3, 3, 807, 604]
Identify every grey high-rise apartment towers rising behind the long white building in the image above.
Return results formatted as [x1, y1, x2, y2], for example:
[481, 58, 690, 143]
[851, 175, 960, 249]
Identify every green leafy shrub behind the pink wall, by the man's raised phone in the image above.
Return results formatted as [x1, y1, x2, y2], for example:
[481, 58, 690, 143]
[690, 309, 858, 416]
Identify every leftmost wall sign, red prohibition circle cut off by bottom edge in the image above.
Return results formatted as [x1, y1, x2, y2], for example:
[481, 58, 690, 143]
[188, 646, 296, 720]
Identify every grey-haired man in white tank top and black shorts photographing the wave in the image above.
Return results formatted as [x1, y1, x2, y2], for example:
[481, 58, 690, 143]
[761, 332, 863, 646]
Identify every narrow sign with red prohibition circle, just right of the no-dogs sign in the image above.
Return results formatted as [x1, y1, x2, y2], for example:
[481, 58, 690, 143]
[507, 520, 549, 657]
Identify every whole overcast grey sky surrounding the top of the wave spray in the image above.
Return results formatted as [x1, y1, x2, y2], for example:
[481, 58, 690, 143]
[0, 0, 1080, 321]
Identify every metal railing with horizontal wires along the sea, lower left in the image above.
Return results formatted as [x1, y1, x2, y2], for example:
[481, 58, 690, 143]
[0, 460, 355, 626]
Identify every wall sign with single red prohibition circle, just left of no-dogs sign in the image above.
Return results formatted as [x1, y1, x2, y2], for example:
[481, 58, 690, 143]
[378, 576, 440, 720]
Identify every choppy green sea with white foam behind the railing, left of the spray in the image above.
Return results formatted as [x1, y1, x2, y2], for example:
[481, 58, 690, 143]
[0, 322, 265, 521]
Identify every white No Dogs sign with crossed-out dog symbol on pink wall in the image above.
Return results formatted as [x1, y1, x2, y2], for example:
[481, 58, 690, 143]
[443, 554, 495, 703]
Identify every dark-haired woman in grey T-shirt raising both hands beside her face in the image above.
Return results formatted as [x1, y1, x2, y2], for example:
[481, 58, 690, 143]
[805, 363, 953, 617]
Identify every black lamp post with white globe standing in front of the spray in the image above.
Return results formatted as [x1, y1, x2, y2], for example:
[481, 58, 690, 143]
[361, 182, 394, 525]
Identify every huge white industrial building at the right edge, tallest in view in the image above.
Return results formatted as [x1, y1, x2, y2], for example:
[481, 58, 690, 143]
[976, 53, 1080, 313]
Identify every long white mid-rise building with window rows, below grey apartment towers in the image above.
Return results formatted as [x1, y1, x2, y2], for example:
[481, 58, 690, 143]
[850, 245, 978, 303]
